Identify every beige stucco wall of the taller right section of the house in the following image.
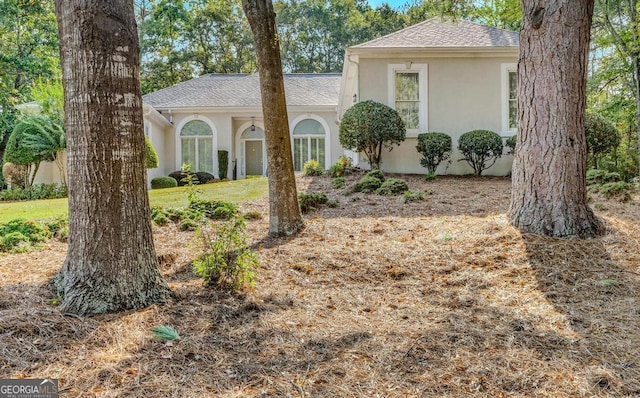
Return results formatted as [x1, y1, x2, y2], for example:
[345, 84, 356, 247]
[359, 56, 517, 175]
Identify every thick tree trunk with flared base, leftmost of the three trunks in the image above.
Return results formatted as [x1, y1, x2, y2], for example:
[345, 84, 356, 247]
[54, 0, 169, 316]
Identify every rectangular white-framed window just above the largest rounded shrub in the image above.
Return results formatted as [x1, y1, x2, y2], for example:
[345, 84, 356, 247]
[389, 62, 427, 132]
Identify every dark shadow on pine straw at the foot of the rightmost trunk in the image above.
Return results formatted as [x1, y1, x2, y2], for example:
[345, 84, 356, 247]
[523, 231, 640, 396]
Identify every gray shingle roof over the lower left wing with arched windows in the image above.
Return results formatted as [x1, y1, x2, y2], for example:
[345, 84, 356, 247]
[143, 73, 341, 108]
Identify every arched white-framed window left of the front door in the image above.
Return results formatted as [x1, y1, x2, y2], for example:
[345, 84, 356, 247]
[180, 120, 213, 174]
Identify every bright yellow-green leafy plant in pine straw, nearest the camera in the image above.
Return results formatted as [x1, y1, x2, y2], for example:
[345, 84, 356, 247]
[193, 217, 258, 290]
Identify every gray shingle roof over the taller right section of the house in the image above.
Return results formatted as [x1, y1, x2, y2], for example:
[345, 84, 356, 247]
[353, 18, 519, 48]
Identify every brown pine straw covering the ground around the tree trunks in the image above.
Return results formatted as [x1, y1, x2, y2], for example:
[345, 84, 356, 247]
[0, 175, 640, 397]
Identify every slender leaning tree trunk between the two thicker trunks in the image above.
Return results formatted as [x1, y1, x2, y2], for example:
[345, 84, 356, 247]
[242, 0, 303, 235]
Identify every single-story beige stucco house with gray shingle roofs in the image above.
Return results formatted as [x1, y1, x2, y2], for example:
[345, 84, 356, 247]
[32, 18, 519, 186]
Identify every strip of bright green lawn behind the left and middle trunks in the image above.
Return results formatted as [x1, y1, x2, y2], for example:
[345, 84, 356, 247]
[0, 178, 268, 223]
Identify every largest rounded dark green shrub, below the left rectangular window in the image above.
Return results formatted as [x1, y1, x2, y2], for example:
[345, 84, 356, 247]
[340, 101, 406, 169]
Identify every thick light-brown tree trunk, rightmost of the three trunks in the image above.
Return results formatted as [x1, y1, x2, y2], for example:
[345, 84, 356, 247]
[509, 0, 604, 237]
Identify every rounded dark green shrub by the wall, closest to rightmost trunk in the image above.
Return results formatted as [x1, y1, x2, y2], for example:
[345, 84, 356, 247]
[458, 130, 503, 176]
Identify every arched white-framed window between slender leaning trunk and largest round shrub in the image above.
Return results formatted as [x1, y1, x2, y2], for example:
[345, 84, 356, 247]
[293, 119, 326, 171]
